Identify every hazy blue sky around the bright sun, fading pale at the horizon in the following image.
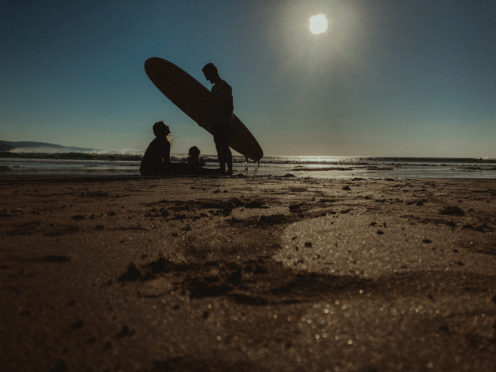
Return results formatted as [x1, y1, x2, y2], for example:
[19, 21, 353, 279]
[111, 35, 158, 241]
[0, 0, 496, 157]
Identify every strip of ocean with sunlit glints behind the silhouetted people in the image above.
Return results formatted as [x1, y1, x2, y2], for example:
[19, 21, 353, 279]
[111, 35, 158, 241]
[0, 154, 496, 179]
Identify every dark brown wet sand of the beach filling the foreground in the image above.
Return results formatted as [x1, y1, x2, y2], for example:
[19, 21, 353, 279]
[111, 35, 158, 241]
[0, 177, 496, 371]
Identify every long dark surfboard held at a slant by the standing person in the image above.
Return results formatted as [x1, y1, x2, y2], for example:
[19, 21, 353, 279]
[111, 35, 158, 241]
[145, 57, 263, 161]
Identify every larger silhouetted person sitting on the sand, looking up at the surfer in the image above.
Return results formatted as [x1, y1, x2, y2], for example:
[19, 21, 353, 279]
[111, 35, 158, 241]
[140, 121, 170, 175]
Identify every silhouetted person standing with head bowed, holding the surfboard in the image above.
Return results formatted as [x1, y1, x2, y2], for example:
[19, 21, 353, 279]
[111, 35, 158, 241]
[202, 63, 234, 175]
